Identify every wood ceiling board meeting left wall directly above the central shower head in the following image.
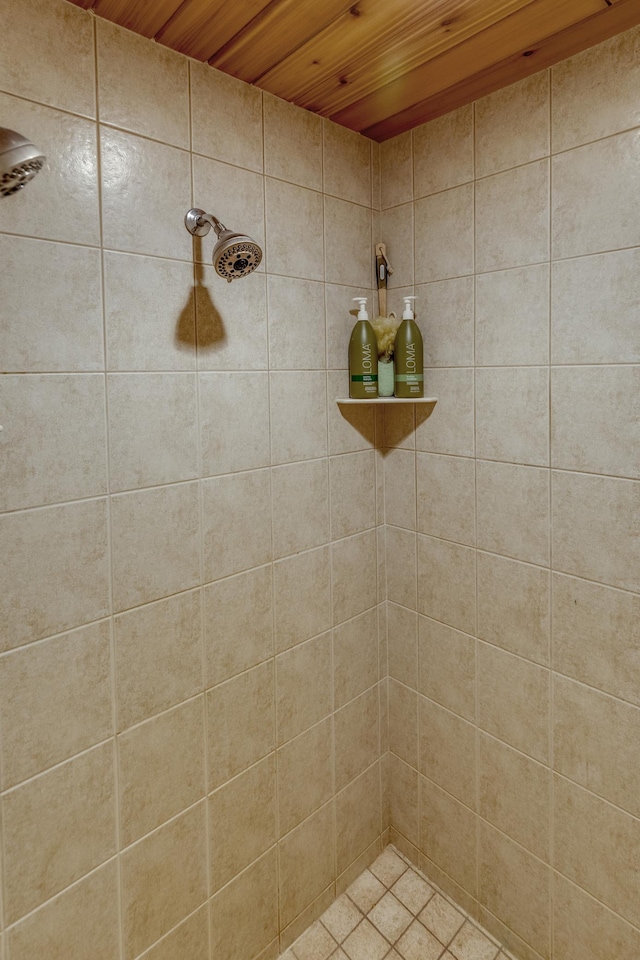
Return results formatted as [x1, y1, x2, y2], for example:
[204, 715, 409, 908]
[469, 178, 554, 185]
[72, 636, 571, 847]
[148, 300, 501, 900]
[209, 0, 353, 83]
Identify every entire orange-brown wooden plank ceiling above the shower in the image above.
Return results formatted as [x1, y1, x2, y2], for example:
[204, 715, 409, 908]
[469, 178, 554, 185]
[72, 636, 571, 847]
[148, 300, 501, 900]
[71, 0, 640, 141]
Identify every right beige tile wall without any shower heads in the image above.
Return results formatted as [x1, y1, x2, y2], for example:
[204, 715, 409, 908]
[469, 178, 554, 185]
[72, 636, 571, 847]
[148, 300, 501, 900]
[381, 22, 640, 960]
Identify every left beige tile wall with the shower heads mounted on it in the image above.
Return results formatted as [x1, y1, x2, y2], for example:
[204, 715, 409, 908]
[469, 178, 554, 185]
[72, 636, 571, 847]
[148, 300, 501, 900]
[0, 0, 388, 960]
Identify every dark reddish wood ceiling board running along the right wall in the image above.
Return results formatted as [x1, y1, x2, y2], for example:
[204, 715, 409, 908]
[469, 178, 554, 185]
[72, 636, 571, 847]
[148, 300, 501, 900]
[362, 0, 640, 143]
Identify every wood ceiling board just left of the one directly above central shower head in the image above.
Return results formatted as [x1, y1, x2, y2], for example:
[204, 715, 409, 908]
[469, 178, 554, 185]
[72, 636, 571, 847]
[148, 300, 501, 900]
[156, 0, 277, 60]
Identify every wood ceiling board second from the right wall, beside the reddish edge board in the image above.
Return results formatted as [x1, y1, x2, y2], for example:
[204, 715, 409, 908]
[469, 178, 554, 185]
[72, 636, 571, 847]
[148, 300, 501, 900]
[331, 0, 612, 132]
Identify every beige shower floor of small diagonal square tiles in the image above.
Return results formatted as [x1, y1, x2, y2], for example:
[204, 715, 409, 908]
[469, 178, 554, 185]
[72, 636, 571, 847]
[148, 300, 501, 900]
[280, 846, 512, 960]
